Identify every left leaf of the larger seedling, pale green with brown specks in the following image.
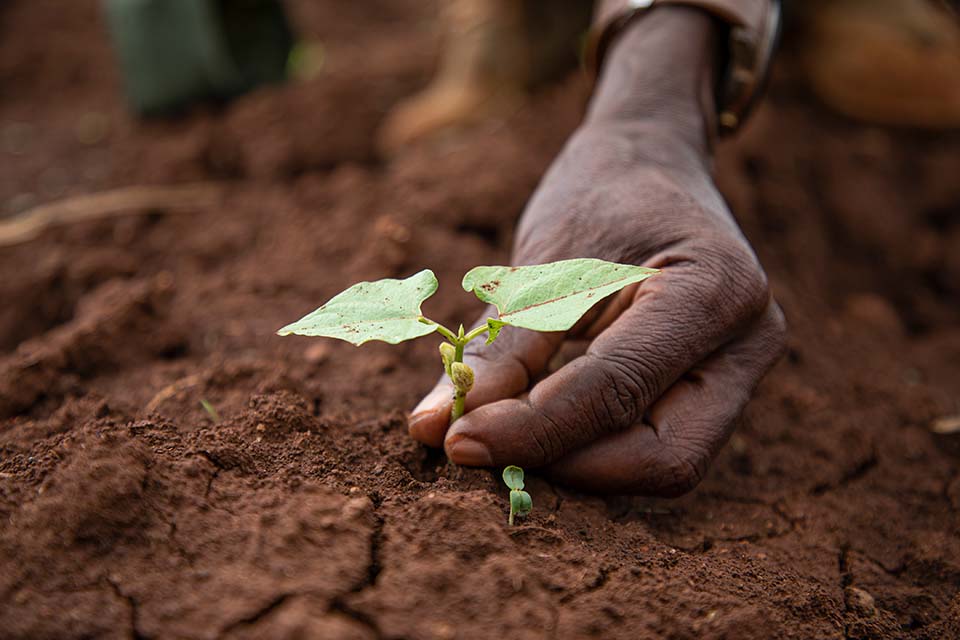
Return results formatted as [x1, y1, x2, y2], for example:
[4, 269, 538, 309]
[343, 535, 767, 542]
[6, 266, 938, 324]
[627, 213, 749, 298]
[277, 269, 437, 346]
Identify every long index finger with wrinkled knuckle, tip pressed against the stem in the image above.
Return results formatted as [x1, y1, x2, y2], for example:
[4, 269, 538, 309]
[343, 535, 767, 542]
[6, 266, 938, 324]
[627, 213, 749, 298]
[444, 250, 769, 466]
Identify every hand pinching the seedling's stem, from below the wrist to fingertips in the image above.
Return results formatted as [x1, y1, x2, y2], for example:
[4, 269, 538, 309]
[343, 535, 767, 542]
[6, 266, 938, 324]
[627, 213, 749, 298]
[410, 6, 785, 496]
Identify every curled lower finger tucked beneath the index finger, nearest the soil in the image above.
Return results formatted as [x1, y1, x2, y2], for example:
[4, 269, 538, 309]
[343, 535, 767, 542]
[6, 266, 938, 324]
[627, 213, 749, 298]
[546, 304, 785, 497]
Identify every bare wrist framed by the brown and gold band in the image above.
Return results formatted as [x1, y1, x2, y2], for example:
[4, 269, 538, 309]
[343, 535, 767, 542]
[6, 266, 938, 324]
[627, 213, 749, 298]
[584, 5, 718, 155]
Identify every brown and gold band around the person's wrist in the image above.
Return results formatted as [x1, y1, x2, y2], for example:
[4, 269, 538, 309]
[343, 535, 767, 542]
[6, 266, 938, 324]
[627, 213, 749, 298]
[584, 0, 780, 134]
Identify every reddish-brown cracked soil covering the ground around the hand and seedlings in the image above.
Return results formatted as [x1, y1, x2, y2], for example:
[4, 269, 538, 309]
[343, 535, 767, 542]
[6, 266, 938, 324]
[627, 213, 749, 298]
[0, 0, 960, 639]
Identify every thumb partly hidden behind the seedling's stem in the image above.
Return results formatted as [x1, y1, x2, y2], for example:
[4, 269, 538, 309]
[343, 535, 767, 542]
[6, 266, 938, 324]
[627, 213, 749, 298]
[409, 307, 563, 447]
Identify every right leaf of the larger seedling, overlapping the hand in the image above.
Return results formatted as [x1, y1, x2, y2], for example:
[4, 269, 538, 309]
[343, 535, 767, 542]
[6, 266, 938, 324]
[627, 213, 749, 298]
[463, 258, 659, 331]
